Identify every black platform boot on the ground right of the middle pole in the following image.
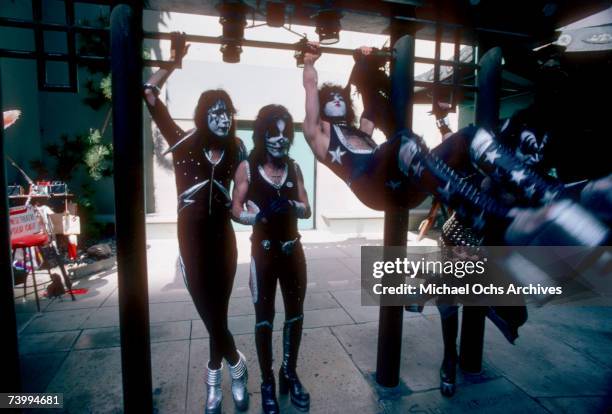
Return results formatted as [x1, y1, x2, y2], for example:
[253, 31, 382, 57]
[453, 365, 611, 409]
[438, 306, 459, 397]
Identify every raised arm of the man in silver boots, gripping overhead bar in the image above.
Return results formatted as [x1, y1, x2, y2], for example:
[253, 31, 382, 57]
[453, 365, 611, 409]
[143, 39, 189, 146]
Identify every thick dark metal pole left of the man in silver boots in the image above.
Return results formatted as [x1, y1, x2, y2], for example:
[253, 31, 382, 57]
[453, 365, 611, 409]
[111, 4, 153, 413]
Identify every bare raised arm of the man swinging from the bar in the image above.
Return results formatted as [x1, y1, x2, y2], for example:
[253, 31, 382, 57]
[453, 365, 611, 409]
[303, 43, 328, 160]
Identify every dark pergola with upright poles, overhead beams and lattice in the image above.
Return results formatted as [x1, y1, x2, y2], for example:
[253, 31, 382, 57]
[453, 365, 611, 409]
[0, 0, 590, 412]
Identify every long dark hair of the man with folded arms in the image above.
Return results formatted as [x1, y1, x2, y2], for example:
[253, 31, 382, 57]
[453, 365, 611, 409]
[249, 104, 293, 165]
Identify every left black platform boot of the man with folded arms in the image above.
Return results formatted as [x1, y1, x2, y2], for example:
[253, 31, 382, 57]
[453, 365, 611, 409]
[255, 321, 280, 414]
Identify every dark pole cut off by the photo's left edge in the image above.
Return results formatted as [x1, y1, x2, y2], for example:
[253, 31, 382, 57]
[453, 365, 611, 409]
[0, 65, 21, 392]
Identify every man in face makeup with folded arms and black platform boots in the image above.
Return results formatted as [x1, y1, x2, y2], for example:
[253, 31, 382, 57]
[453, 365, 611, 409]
[232, 105, 310, 414]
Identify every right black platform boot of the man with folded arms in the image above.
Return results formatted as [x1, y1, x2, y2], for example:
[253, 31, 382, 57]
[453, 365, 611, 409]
[278, 315, 310, 411]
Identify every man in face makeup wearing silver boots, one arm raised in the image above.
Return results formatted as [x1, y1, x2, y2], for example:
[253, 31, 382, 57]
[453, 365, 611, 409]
[144, 36, 249, 414]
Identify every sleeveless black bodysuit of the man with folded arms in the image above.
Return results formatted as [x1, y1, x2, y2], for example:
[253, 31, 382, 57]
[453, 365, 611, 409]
[247, 160, 306, 381]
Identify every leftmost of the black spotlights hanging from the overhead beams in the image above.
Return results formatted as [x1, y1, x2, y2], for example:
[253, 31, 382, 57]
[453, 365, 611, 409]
[217, 0, 247, 63]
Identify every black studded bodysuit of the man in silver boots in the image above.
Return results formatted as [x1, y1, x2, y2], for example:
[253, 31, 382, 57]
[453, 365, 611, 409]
[149, 95, 246, 365]
